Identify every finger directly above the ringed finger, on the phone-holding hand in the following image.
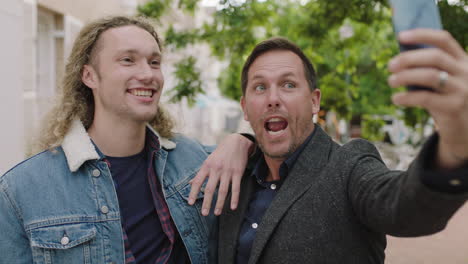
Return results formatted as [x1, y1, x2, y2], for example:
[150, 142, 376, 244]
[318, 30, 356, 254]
[388, 48, 463, 75]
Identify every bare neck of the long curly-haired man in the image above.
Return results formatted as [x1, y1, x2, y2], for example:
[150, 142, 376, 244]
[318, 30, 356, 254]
[88, 115, 146, 157]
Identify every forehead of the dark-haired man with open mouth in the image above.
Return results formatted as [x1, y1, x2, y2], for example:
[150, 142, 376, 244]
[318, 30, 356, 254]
[248, 50, 305, 79]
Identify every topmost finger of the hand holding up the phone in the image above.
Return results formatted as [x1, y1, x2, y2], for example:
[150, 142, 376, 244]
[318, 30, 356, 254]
[398, 28, 466, 59]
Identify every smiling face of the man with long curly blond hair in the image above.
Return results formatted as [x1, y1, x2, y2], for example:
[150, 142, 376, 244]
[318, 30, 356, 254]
[82, 25, 164, 122]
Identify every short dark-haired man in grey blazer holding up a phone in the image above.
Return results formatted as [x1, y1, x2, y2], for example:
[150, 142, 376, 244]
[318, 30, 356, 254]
[218, 33, 468, 264]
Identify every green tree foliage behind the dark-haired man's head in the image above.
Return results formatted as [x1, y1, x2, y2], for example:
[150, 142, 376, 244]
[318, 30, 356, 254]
[139, 0, 468, 142]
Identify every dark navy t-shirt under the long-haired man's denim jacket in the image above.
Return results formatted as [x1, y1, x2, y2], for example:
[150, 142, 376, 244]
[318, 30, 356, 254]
[106, 149, 167, 263]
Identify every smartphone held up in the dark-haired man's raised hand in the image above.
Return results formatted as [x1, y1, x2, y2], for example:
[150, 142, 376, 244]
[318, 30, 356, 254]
[390, 0, 442, 91]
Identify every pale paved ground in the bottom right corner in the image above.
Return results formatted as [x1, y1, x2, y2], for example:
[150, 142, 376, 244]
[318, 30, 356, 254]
[385, 204, 468, 264]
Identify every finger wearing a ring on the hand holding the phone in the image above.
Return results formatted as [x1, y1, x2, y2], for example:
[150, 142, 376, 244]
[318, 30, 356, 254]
[388, 68, 455, 93]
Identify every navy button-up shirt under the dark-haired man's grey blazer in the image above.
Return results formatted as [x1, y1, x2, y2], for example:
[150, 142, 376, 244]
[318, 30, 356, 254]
[236, 129, 316, 264]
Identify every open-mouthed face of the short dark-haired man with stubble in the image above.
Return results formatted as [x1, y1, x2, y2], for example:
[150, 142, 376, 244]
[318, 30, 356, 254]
[241, 50, 320, 161]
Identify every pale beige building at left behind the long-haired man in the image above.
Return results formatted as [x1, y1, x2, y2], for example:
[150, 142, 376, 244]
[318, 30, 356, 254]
[0, 0, 143, 175]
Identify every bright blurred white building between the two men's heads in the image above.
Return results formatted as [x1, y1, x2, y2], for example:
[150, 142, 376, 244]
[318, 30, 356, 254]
[162, 6, 250, 145]
